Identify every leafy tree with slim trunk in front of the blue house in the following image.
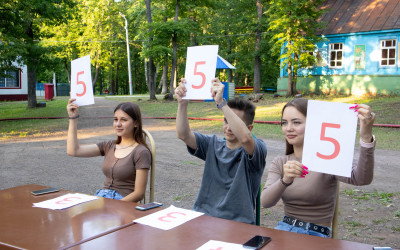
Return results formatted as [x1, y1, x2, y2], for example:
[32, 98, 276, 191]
[268, 0, 323, 96]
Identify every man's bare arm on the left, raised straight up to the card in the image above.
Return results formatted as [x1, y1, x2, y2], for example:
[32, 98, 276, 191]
[175, 79, 197, 150]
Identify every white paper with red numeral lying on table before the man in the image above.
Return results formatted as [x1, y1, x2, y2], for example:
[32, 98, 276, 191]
[133, 205, 204, 230]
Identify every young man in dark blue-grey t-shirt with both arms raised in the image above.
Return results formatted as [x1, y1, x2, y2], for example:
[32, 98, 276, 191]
[175, 78, 267, 224]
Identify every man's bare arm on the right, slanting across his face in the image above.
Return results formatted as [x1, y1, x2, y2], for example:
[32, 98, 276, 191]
[211, 78, 255, 155]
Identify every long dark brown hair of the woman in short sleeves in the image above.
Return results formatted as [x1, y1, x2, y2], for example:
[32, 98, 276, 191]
[114, 102, 151, 152]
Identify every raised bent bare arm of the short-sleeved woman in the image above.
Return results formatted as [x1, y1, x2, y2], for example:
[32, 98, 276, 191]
[67, 99, 101, 157]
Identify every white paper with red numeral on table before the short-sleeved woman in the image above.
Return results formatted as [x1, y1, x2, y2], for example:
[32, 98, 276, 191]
[33, 193, 98, 210]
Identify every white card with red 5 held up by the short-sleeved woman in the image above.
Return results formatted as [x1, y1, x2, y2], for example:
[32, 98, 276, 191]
[71, 55, 94, 106]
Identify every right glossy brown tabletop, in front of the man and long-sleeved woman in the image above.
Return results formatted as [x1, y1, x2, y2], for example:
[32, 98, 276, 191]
[67, 211, 372, 250]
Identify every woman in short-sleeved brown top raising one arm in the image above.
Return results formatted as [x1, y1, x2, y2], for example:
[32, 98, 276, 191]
[67, 99, 151, 202]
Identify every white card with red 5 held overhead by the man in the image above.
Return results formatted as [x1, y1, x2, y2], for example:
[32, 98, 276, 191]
[183, 45, 218, 100]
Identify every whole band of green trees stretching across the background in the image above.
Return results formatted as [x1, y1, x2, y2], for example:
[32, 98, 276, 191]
[0, 0, 321, 99]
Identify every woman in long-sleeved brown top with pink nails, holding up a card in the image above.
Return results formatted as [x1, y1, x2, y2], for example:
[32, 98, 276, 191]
[261, 98, 375, 237]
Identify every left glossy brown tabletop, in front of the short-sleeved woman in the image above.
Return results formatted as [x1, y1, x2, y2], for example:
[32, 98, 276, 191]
[0, 185, 160, 250]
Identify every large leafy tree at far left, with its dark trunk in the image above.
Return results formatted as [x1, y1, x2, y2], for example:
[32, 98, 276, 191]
[0, 0, 73, 108]
